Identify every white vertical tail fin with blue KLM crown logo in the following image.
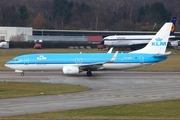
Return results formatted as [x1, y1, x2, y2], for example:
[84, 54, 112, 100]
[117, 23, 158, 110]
[131, 22, 172, 54]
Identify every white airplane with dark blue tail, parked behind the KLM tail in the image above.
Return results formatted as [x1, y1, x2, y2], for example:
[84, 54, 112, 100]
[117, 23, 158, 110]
[101, 17, 176, 50]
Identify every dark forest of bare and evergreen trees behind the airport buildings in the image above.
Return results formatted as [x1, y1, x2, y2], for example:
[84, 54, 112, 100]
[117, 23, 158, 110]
[0, 0, 180, 31]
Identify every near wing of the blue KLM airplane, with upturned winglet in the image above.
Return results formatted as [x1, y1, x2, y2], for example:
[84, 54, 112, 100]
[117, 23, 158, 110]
[78, 51, 118, 70]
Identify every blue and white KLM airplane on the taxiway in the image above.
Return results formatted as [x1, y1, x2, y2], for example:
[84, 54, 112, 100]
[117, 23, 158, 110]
[5, 23, 172, 76]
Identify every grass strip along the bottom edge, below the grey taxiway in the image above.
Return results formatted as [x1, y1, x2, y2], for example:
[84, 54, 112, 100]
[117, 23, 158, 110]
[5, 100, 180, 120]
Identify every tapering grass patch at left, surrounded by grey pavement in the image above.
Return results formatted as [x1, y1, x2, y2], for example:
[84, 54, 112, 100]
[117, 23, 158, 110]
[0, 82, 89, 98]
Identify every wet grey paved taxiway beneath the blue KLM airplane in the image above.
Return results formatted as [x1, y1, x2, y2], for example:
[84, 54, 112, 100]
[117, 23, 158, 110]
[0, 71, 180, 116]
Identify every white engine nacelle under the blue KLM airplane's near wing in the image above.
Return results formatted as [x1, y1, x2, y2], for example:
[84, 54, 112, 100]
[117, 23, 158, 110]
[62, 66, 80, 74]
